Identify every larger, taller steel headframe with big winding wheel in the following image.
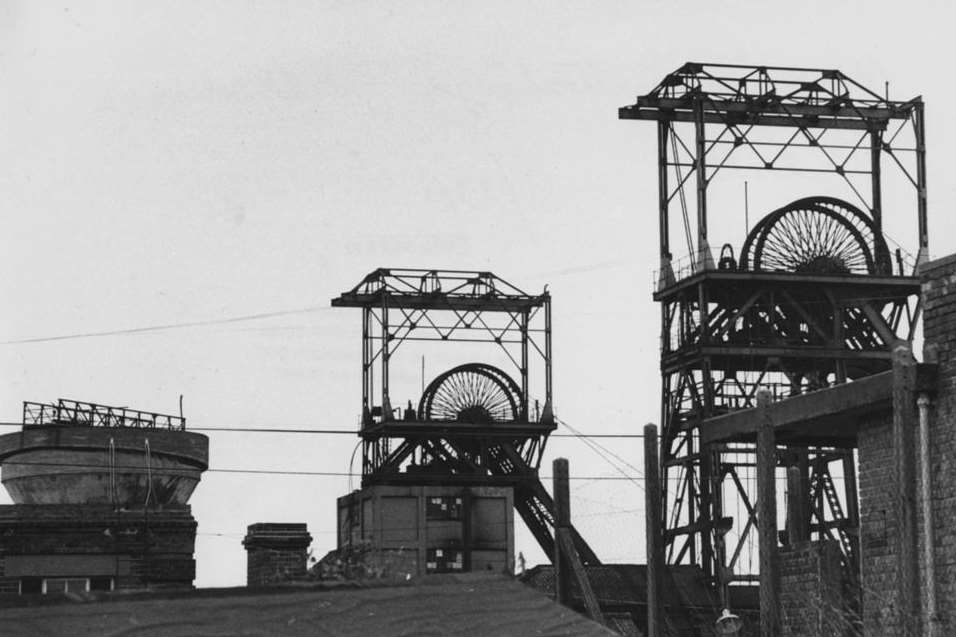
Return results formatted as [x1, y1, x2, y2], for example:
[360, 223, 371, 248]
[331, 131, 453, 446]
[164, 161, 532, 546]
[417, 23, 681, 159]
[619, 63, 928, 595]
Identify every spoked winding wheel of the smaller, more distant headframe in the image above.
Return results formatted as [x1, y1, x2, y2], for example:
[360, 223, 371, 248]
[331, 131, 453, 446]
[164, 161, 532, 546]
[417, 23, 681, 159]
[418, 363, 521, 424]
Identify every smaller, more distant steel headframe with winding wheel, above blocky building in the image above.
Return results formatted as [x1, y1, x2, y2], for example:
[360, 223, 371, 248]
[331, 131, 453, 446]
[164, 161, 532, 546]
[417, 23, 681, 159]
[332, 268, 599, 563]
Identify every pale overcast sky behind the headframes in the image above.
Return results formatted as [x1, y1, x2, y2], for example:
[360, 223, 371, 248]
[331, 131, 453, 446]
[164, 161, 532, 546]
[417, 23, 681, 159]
[0, 0, 956, 586]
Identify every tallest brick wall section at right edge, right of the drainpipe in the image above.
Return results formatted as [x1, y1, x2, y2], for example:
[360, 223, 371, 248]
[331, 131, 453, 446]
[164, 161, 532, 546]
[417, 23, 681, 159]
[917, 255, 956, 635]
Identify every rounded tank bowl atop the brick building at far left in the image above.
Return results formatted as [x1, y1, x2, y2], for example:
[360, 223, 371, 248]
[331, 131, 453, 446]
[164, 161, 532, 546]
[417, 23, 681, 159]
[0, 424, 209, 508]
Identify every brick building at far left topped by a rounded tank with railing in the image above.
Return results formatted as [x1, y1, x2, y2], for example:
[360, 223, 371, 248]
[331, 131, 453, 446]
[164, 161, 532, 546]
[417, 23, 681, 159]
[0, 400, 209, 595]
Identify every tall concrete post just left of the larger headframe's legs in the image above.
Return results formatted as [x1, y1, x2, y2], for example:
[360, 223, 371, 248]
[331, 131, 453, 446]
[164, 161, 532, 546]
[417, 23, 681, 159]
[644, 424, 664, 637]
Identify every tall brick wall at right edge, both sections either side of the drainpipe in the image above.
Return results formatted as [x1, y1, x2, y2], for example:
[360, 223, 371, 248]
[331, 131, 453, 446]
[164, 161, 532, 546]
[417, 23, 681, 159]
[859, 255, 956, 636]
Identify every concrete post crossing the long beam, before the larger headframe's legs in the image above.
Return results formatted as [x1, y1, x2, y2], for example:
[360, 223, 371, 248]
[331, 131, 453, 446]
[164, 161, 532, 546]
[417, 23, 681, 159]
[757, 389, 780, 637]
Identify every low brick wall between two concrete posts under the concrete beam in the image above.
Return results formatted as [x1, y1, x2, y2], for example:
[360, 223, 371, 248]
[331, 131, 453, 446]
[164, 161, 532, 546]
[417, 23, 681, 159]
[780, 541, 855, 637]
